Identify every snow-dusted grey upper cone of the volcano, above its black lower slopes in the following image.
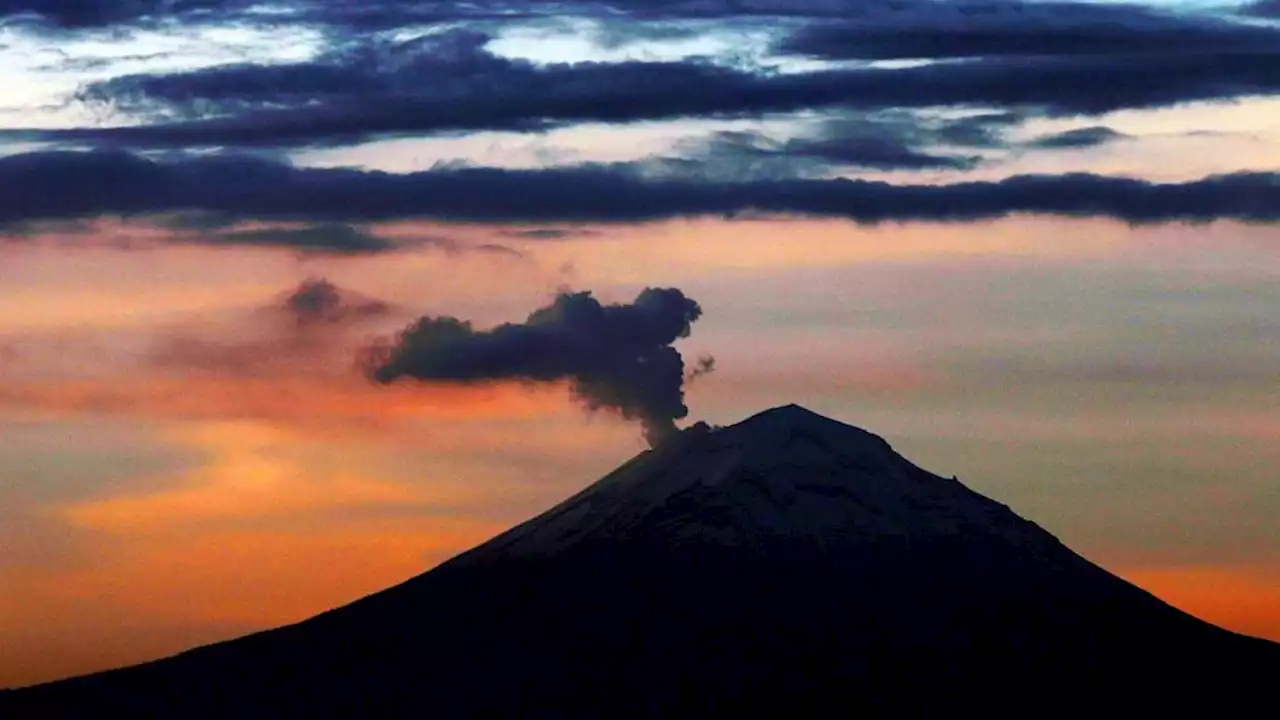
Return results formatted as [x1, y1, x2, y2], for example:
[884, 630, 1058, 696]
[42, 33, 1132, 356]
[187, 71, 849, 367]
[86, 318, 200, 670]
[458, 405, 1057, 562]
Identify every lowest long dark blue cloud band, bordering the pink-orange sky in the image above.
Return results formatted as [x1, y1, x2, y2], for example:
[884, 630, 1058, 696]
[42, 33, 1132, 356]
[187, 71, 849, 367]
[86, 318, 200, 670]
[0, 152, 1280, 223]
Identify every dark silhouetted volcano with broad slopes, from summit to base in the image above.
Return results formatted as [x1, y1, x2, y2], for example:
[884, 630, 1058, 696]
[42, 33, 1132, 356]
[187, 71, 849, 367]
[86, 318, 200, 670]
[0, 406, 1280, 717]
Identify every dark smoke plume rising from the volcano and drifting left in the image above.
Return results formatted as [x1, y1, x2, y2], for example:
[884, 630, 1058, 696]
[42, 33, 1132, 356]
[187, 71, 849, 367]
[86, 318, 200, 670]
[366, 288, 703, 446]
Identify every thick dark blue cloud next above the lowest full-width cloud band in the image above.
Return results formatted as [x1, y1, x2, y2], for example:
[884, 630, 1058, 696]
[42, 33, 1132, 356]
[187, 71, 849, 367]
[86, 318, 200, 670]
[22, 15, 1280, 149]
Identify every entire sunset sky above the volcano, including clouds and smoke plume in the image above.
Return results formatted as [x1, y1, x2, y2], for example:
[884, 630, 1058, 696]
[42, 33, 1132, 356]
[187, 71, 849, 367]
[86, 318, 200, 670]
[0, 0, 1280, 687]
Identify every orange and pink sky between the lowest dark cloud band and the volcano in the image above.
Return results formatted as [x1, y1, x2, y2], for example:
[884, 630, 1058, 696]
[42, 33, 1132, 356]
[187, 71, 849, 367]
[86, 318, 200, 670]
[0, 218, 1280, 685]
